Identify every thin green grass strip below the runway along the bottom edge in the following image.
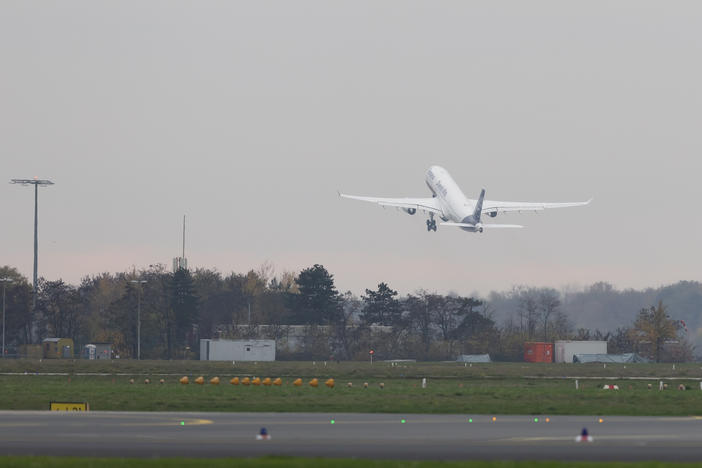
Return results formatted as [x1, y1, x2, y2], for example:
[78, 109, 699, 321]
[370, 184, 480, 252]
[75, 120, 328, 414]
[0, 457, 702, 468]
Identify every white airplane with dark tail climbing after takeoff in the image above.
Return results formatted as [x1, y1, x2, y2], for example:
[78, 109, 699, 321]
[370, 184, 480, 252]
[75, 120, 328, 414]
[339, 166, 592, 232]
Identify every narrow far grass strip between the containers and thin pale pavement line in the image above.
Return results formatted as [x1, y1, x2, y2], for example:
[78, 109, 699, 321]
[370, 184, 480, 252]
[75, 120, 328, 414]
[0, 359, 702, 379]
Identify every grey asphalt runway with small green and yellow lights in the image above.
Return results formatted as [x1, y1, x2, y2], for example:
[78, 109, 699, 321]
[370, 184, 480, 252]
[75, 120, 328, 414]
[0, 411, 702, 461]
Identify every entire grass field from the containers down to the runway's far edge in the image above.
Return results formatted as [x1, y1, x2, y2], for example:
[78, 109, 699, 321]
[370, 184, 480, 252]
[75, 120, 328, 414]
[0, 361, 702, 416]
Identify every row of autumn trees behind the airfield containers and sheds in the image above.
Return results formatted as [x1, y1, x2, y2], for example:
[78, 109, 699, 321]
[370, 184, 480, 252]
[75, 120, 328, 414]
[0, 264, 693, 361]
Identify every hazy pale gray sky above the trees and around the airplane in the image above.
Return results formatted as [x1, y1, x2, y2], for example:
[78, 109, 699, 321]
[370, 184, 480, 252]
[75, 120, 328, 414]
[0, 0, 702, 294]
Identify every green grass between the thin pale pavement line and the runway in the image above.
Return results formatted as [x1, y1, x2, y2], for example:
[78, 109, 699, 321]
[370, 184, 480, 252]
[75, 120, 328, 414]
[0, 374, 702, 416]
